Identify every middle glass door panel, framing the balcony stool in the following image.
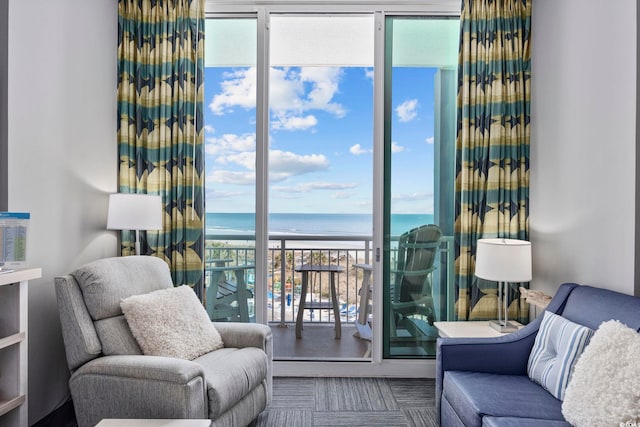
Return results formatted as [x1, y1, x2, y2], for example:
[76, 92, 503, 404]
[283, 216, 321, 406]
[268, 14, 374, 360]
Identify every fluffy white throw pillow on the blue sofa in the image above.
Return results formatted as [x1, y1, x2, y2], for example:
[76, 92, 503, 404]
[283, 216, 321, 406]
[562, 320, 640, 427]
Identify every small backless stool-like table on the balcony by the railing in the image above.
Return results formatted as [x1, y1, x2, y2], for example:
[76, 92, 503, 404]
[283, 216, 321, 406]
[295, 264, 342, 340]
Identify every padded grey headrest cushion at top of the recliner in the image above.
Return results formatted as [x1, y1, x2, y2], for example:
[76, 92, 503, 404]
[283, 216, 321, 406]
[71, 256, 173, 320]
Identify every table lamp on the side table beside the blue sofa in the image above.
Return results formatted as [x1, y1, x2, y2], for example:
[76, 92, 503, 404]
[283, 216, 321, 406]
[475, 239, 531, 332]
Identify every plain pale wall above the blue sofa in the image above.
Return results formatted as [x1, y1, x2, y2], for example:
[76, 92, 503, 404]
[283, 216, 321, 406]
[530, 0, 637, 294]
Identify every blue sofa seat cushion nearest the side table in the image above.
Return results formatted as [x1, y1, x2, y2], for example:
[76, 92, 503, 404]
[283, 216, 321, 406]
[442, 371, 564, 426]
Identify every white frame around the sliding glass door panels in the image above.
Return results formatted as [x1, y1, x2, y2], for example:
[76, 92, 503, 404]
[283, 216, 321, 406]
[206, 0, 460, 378]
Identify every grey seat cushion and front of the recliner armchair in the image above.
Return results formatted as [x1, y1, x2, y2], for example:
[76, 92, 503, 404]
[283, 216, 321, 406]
[194, 347, 269, 419]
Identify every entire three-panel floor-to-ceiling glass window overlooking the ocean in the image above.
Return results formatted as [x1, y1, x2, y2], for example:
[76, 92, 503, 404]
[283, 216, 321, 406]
[205, 2, 459, 372]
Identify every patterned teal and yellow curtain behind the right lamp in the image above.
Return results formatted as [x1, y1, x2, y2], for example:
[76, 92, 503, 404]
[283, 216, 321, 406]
[455, 0, 532, 322]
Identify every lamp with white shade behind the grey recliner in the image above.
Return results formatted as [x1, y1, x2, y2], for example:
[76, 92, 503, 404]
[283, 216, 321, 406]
[107, 193, 162, 255]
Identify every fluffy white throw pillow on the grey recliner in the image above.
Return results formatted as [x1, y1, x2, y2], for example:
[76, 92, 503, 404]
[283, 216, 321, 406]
[120, 286, 224, 360]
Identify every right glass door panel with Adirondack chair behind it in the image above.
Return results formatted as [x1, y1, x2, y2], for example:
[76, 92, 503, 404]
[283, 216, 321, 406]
[383, 16, 459, 358]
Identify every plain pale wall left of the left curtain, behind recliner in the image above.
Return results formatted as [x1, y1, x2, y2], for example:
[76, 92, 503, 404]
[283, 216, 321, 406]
[8, 0, 117, 424]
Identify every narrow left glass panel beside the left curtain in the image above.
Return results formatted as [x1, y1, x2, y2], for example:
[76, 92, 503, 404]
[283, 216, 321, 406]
[204, 17, 257, 322]
